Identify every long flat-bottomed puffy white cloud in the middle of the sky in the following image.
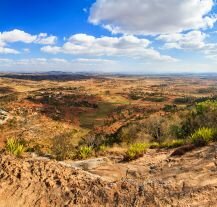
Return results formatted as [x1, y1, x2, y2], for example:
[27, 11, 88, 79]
[41, 34, 175, 61]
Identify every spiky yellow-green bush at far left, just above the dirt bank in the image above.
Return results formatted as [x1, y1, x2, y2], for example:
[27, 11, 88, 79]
[5, 138, 26, 157]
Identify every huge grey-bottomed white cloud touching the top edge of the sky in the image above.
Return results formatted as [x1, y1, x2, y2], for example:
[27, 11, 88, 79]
[89, 0, 216, 35]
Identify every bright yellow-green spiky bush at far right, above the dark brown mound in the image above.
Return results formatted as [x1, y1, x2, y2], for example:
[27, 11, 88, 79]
[190, 127, 214, 147]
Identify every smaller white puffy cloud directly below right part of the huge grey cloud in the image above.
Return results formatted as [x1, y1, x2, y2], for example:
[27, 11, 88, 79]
[157, 31, 207, 50]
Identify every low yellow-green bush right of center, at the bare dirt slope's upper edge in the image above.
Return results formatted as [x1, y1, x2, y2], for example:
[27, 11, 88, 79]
[125, 143, 149, 161]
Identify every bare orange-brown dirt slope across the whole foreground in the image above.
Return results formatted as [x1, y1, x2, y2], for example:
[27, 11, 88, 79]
[0, 145, 217, 207]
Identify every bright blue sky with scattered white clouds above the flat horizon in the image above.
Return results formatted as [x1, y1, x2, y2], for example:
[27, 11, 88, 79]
[0, 0, 217, 74]
